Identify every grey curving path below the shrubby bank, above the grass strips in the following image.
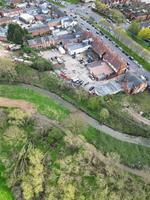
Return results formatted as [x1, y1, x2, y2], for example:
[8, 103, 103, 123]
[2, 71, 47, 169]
[21, 84, 150, 147]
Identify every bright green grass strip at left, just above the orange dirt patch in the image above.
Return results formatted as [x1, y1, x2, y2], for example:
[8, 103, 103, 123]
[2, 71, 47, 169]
[0, 85, 69, 121]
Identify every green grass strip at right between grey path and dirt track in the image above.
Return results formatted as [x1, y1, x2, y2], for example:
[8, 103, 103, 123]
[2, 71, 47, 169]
[83, 127, 150, 167]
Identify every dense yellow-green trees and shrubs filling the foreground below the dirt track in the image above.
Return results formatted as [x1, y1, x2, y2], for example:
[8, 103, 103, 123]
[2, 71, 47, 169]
[0, 104, 150, 200]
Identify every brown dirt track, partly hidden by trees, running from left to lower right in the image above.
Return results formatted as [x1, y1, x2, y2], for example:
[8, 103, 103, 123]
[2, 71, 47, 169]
[0, 94, 150, 180]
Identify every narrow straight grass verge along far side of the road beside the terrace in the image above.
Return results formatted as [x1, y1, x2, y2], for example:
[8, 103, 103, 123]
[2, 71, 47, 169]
[93, 23, 150, 71]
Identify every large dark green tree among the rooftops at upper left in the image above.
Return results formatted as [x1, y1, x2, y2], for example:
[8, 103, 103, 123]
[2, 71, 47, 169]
[7, 24, 27, 44]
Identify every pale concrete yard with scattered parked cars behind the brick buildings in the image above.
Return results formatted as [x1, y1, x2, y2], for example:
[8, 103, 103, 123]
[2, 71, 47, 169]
[40, 49, 121, 93]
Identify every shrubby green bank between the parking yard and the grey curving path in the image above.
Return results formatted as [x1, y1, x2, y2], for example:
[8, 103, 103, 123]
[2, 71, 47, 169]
[1, 55, 150, 137]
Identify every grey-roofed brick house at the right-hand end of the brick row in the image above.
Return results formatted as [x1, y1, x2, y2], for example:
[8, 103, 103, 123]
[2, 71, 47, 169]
[123, 71, 147, 94]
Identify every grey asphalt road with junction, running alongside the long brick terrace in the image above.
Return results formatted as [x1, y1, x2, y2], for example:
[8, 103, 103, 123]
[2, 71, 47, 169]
[59, 3, 150, 81]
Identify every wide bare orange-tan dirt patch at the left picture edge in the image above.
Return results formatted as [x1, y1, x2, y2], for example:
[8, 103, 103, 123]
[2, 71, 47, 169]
[0, 97, 36, 114]
